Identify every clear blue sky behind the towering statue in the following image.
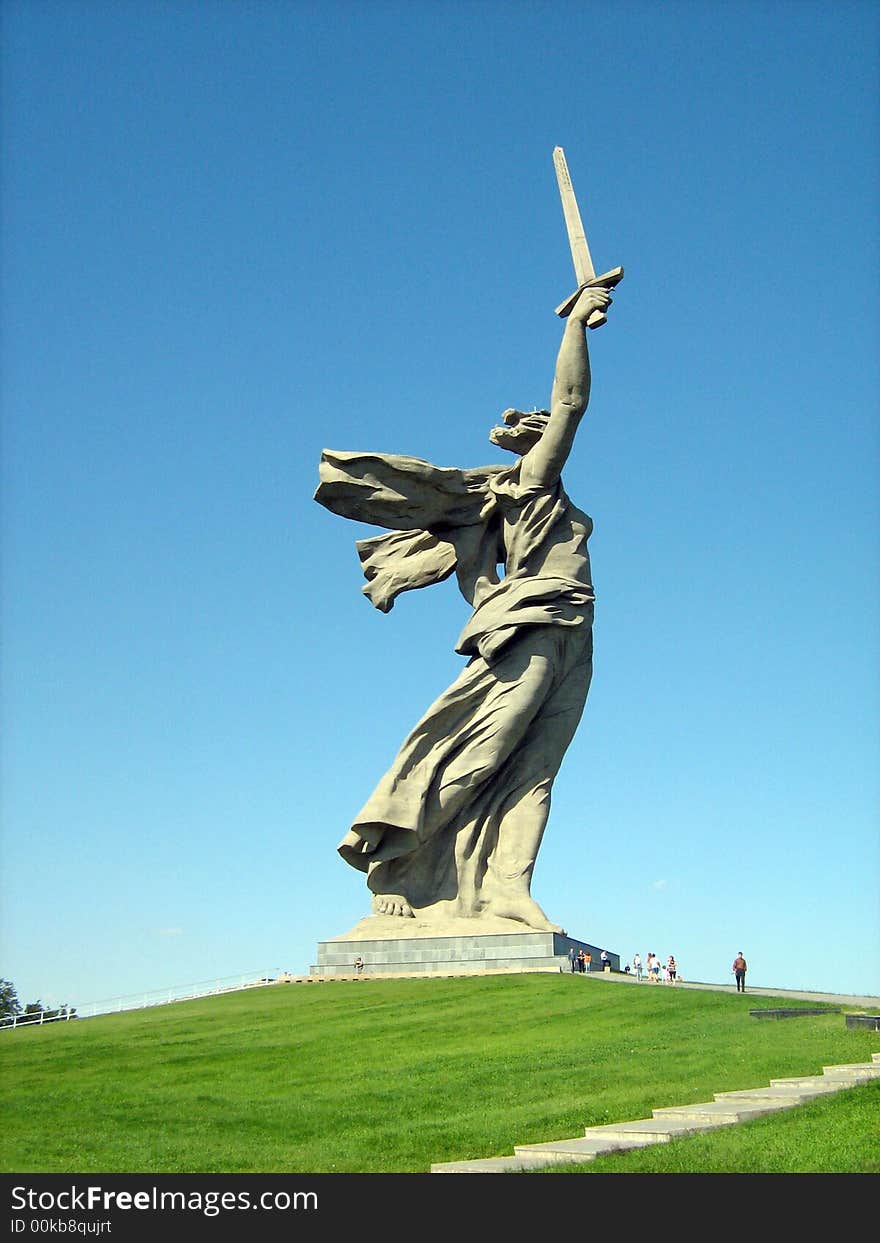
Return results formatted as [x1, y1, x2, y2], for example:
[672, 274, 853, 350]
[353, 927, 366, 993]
[0, 0, 880, 1004]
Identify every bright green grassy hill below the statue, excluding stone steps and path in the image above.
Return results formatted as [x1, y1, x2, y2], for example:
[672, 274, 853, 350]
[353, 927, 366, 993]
[0, 973, 880, 1173]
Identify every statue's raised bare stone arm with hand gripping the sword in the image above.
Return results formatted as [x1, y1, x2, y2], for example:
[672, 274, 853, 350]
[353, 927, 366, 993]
[520, 287, 612, 487]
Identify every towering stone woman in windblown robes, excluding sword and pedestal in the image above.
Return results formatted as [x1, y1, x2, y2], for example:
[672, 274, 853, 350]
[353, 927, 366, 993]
[314, 288, 612, 932]
